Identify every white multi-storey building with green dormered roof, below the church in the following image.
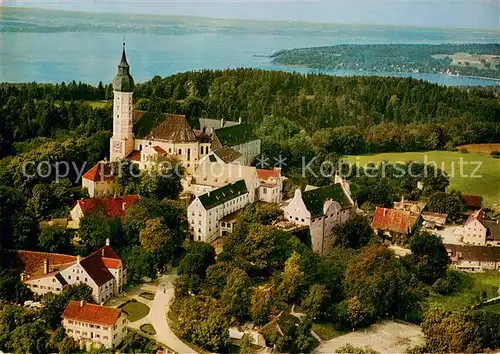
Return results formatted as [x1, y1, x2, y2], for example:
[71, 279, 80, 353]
[188, 179, 250, 243]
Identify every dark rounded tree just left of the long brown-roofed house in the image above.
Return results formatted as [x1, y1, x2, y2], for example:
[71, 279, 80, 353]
[409, 232, 450, 284]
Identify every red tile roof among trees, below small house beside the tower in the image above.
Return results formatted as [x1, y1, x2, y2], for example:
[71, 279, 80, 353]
[76, 194, 140, 218]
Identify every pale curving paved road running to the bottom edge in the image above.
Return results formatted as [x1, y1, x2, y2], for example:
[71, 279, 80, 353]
[148, 274, 196, 354]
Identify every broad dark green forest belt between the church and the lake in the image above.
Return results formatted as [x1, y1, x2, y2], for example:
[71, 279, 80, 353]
[0, 69, 500, 156]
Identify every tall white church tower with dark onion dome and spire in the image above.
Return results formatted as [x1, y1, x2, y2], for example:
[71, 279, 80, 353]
[109, 42, 134, 161]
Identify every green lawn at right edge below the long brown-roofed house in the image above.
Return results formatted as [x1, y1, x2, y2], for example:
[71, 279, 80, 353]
[429, 272, 500, 313]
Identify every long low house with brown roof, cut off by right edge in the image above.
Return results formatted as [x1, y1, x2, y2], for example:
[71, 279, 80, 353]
[445, 244, 500, 272]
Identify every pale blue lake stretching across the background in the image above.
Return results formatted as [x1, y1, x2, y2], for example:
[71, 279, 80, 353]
[0, 7, 500, 86]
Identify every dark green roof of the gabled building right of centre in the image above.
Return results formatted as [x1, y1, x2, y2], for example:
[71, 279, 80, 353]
[302, 183, 351, 217]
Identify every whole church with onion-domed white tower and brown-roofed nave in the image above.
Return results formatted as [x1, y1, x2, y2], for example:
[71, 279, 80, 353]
[110, 43, 260, 174]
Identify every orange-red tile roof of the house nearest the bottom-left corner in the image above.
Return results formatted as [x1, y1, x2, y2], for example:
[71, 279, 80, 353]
[62, 301, 121, 327]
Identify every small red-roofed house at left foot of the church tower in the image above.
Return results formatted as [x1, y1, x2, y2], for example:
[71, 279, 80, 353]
[82, 161, 116, 198]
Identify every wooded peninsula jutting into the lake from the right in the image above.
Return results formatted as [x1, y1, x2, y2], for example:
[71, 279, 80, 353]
[271, 43, 500, 78]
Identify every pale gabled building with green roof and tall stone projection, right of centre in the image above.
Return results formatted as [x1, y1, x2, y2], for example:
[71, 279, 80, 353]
[283, 177, 357, 254]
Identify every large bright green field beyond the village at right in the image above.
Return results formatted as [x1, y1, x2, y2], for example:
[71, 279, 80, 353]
[346, 151, 500, 207]
